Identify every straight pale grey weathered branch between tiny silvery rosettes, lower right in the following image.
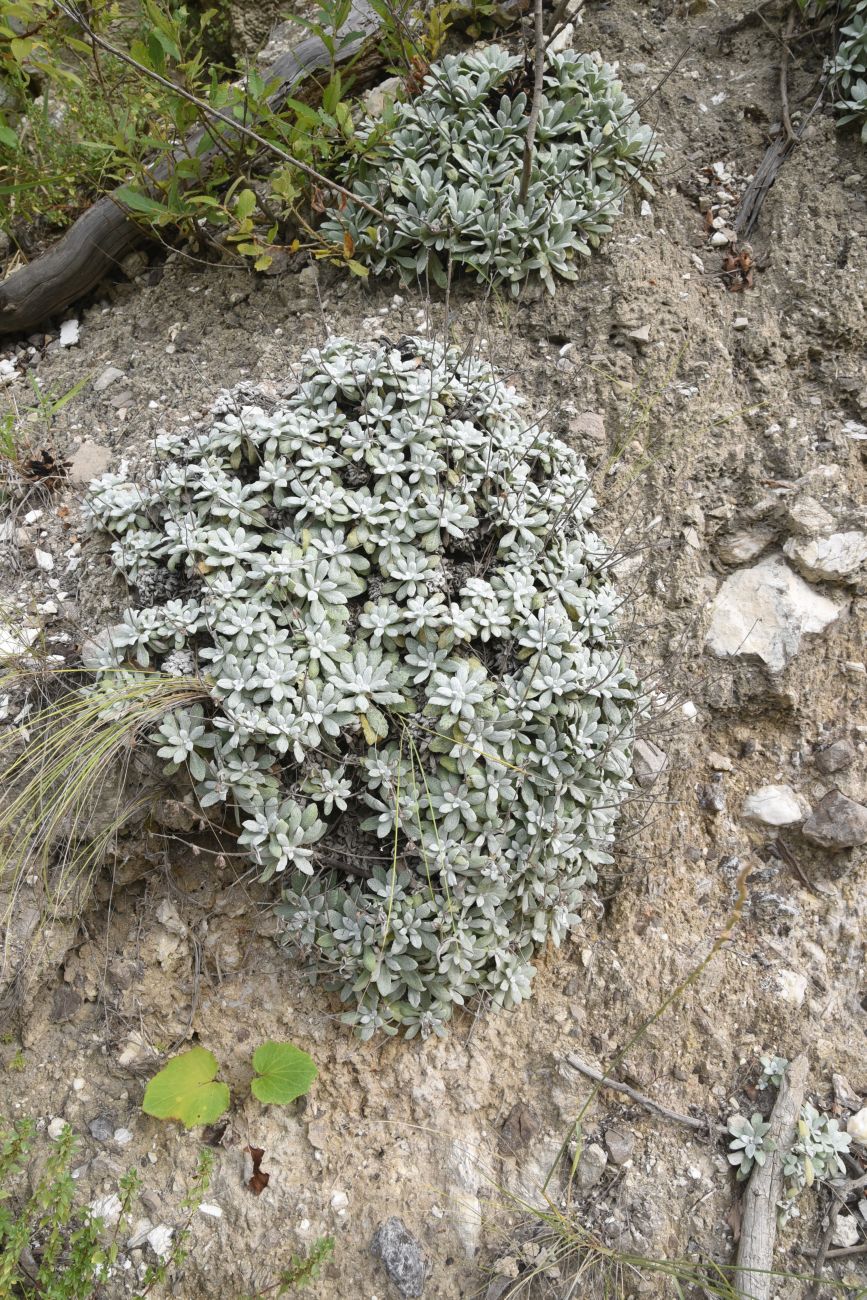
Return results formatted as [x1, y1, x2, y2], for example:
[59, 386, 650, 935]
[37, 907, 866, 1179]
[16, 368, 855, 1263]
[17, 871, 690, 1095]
[734, 1053, 807, 1300]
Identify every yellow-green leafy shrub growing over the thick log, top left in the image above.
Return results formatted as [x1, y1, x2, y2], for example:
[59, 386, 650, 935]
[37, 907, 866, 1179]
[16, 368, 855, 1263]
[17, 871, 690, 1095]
[0, 0, 382, 270]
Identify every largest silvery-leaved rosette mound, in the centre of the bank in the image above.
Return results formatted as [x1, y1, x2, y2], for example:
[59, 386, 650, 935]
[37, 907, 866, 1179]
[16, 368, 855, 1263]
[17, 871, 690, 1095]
[88, 338, 642, 1037]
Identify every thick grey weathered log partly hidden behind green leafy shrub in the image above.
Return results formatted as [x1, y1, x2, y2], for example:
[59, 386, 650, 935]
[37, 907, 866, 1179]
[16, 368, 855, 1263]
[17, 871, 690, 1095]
[0, 0, 383, 334]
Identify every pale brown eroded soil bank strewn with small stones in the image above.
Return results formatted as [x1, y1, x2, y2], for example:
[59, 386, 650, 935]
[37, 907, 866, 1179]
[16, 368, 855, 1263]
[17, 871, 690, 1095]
[0, 0, 867, 1300]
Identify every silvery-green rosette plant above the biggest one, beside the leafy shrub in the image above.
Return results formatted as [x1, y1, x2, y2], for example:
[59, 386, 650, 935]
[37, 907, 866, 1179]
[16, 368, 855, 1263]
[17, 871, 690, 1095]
[321, 46, 659, 294]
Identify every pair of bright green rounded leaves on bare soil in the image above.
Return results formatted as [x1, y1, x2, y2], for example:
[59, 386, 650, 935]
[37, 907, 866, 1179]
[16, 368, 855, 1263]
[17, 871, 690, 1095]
[142, 1040, 317, 1128]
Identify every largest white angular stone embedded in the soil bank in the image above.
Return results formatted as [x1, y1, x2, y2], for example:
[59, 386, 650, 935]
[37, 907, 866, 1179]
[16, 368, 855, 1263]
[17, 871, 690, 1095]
[705, 555, 840, 672]
